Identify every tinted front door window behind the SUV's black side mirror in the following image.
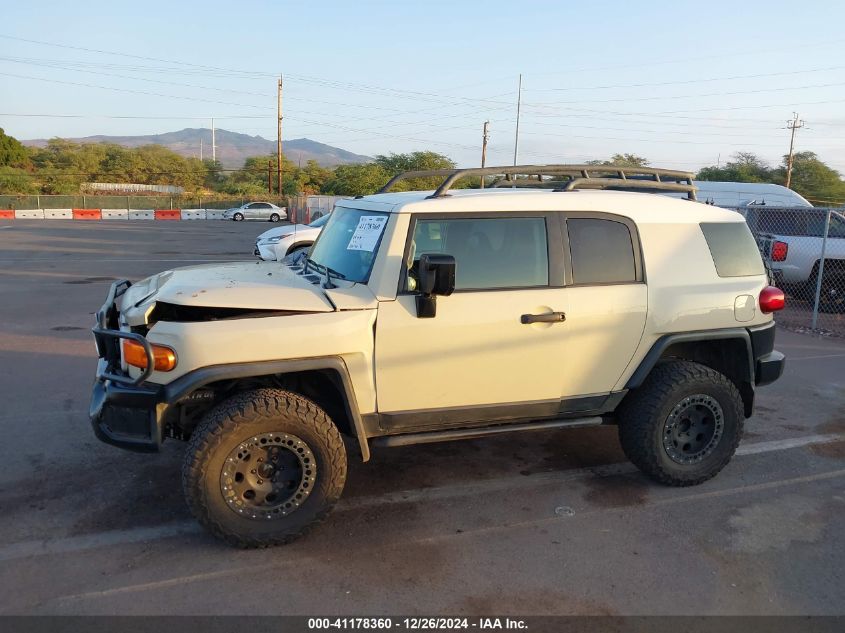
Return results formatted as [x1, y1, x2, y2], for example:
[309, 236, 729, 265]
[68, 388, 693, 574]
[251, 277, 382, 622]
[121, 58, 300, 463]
[410, 218, 549, 289]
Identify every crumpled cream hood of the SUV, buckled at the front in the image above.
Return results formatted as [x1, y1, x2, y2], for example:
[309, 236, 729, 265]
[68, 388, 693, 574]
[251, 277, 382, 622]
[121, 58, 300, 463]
[120, 261, 335, 324]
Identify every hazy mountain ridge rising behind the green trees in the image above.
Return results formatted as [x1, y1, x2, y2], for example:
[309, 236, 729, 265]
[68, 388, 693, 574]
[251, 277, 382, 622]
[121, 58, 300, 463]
[21, 128, 372, 168]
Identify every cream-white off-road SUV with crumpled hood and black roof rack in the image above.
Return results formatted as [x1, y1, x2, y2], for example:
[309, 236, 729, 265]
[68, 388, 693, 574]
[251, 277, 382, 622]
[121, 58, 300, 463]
[91, 166, 784, 547]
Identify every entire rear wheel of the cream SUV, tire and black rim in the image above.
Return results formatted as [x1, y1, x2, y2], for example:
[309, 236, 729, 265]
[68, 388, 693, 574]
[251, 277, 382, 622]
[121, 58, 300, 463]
[619, 361, 745, 486]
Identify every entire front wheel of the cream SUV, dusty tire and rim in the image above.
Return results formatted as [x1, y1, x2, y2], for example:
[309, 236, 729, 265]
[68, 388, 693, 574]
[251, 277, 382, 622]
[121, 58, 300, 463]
[182, 389, 346, 548]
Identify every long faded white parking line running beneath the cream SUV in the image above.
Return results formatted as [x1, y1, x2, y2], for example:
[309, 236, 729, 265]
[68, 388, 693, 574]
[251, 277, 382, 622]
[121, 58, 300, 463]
[0, 434, 845, 561]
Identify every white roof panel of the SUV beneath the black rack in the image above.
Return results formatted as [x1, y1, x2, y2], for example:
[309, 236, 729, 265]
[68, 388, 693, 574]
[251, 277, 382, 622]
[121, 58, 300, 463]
[337, 188, 744, 223]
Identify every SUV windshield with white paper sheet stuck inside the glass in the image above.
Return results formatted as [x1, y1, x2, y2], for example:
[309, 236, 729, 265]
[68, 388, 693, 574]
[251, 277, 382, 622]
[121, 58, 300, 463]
[308, 207, 388, 283]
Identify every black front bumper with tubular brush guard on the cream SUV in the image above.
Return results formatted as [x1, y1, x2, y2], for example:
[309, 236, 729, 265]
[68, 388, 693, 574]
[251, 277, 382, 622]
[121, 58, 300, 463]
[88, 280, 168, 452]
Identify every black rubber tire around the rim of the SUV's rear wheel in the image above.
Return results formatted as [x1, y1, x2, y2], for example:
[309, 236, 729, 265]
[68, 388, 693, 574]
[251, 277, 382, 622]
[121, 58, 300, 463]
[618, 361, 745, 486]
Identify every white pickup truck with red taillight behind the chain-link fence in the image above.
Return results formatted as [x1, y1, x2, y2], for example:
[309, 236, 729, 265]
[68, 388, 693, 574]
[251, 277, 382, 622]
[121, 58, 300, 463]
[744, 207, 845, 312]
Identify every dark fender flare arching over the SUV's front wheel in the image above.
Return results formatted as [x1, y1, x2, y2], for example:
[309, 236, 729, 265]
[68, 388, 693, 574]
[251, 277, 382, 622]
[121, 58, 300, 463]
[160, 356, 370, 462]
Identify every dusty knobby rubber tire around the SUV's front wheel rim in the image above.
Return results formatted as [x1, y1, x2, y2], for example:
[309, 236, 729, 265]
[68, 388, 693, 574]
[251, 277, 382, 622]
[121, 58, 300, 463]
[182, 389, 346, 548]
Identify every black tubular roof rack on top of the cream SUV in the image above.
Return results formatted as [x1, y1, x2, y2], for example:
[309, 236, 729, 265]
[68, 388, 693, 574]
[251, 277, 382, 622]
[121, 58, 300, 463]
[378, 165, 696, 200]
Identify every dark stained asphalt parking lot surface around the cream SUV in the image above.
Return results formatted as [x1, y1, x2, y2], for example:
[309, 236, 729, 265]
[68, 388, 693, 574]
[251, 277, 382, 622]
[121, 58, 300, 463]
[0, 220, 845, 615]
